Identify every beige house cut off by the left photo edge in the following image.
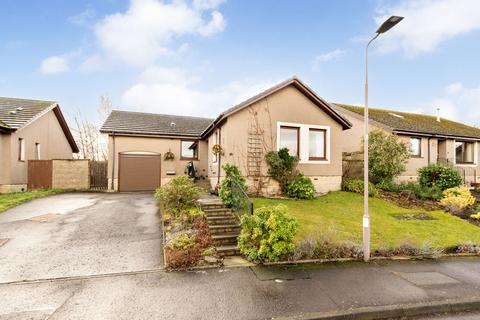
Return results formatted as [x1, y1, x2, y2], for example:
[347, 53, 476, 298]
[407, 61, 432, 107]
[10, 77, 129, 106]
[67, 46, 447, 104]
[0, 97, 78, 193]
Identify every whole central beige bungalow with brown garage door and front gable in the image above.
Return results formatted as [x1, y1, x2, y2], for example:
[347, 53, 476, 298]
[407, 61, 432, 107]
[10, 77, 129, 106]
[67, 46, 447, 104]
[101, 77, 351, 195]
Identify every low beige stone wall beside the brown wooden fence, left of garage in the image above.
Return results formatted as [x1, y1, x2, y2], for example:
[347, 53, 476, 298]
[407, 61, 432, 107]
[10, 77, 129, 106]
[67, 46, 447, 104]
[52, 160, 90, 190]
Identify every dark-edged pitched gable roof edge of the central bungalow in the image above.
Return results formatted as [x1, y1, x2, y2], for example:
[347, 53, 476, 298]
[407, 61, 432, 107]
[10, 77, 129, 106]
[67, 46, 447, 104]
[202, 77, 352, 136]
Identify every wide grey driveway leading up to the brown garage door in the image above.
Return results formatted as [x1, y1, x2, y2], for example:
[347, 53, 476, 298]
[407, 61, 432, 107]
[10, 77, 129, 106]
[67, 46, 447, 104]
[0, 193, 163, 283]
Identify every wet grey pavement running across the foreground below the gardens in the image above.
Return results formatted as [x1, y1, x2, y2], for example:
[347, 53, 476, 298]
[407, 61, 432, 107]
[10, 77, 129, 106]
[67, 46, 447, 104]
[0, 258, 480, 320]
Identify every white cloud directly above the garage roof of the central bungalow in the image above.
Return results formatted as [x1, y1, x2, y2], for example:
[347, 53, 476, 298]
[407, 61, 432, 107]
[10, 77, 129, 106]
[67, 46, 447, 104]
[122, 67, 273, 117]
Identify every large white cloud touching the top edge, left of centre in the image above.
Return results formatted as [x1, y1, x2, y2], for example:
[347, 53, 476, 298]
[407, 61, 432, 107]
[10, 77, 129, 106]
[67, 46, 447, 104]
[95, 0, 225, 66]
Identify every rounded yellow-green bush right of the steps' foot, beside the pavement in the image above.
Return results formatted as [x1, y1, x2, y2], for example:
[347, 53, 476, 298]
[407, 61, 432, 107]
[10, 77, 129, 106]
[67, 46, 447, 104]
[238, 205, 298, 261]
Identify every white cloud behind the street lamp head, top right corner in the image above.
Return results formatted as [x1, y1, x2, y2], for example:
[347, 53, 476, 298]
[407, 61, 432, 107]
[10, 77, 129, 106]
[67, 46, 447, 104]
[375, 0, 480, 57]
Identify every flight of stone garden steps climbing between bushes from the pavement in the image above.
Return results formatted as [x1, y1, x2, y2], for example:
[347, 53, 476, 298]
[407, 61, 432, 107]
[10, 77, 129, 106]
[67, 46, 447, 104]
[198, 198, 241, 257]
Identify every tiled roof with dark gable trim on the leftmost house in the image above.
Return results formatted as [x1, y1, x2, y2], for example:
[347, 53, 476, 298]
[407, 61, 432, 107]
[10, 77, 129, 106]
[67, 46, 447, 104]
[0, 97, 78, 153]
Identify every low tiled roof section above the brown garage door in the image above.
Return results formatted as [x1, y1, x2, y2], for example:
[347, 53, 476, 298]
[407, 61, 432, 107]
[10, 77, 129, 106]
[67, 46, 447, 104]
[100, 110, 213, 138]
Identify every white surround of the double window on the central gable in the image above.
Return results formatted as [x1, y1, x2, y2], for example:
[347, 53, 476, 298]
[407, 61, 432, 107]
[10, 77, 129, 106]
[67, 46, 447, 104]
[277, 122, 331, 164]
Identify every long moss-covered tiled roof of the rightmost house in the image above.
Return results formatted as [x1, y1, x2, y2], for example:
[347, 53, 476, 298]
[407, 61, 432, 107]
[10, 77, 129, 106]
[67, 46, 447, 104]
[335, 103, 480, 139]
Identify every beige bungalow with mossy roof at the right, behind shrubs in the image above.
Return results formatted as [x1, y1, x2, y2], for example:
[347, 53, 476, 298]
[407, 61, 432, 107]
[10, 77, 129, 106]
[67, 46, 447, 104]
[332, 104, 480, 184]
